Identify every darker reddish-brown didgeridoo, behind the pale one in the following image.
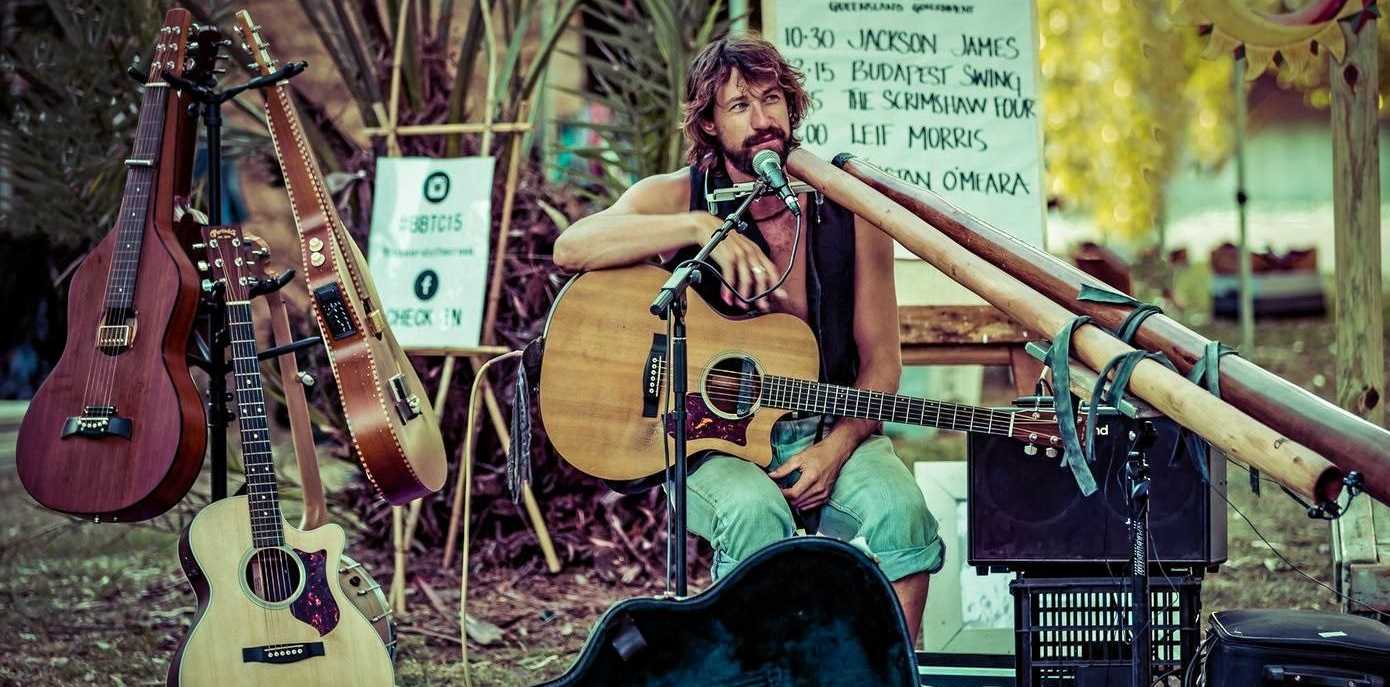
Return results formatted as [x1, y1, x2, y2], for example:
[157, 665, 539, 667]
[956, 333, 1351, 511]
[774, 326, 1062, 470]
[842, 151, 1390, 502]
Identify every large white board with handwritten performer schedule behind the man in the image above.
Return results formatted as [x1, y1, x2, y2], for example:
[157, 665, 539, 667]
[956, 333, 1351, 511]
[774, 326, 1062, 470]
[765, 0, 1045, 257]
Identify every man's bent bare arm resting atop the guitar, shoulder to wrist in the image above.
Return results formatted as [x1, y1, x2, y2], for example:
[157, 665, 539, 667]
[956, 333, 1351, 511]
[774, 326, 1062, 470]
[555, 172, 712, 271]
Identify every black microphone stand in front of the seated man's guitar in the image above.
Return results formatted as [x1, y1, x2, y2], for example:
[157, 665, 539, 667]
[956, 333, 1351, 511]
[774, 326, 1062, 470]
[651, 178, 769, 597]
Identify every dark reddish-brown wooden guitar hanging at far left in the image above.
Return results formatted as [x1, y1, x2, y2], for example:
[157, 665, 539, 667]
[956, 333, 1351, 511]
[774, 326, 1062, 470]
[15, 8, 221, 522]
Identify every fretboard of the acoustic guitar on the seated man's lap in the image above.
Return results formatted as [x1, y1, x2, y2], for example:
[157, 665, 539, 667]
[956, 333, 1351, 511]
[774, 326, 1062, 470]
[762, 375, 1015, 437]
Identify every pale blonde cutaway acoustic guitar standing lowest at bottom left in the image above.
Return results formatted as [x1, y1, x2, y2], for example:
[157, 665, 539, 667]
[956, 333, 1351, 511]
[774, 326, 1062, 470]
[168, 227, 393, 687]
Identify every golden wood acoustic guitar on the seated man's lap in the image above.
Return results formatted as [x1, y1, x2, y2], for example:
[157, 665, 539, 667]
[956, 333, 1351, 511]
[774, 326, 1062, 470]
[541, 266, 1062, 480]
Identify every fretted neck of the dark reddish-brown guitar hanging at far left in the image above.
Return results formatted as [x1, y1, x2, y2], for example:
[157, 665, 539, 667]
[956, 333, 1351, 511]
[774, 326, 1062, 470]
[106, 83, 170, 316]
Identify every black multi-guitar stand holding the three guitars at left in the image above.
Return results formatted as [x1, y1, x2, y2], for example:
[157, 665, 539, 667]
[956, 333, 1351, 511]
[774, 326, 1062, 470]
[176, 57, 312, 501]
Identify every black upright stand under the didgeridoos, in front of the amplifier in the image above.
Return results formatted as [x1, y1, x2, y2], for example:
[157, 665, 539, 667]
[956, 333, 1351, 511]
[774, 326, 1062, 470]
[1125, 420, 1158, 686]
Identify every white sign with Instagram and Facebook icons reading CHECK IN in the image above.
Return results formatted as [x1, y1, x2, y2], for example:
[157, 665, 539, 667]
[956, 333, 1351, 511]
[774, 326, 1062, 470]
[367, 157, 493, 349]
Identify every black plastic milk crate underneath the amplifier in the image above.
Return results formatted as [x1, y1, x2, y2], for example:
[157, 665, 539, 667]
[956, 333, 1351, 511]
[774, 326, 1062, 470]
[1009, 574, 1202, 687]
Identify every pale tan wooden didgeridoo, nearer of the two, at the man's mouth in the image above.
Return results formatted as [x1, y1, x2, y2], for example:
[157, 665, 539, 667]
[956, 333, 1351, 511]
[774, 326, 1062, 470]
[787, 149, 1341, 502]
